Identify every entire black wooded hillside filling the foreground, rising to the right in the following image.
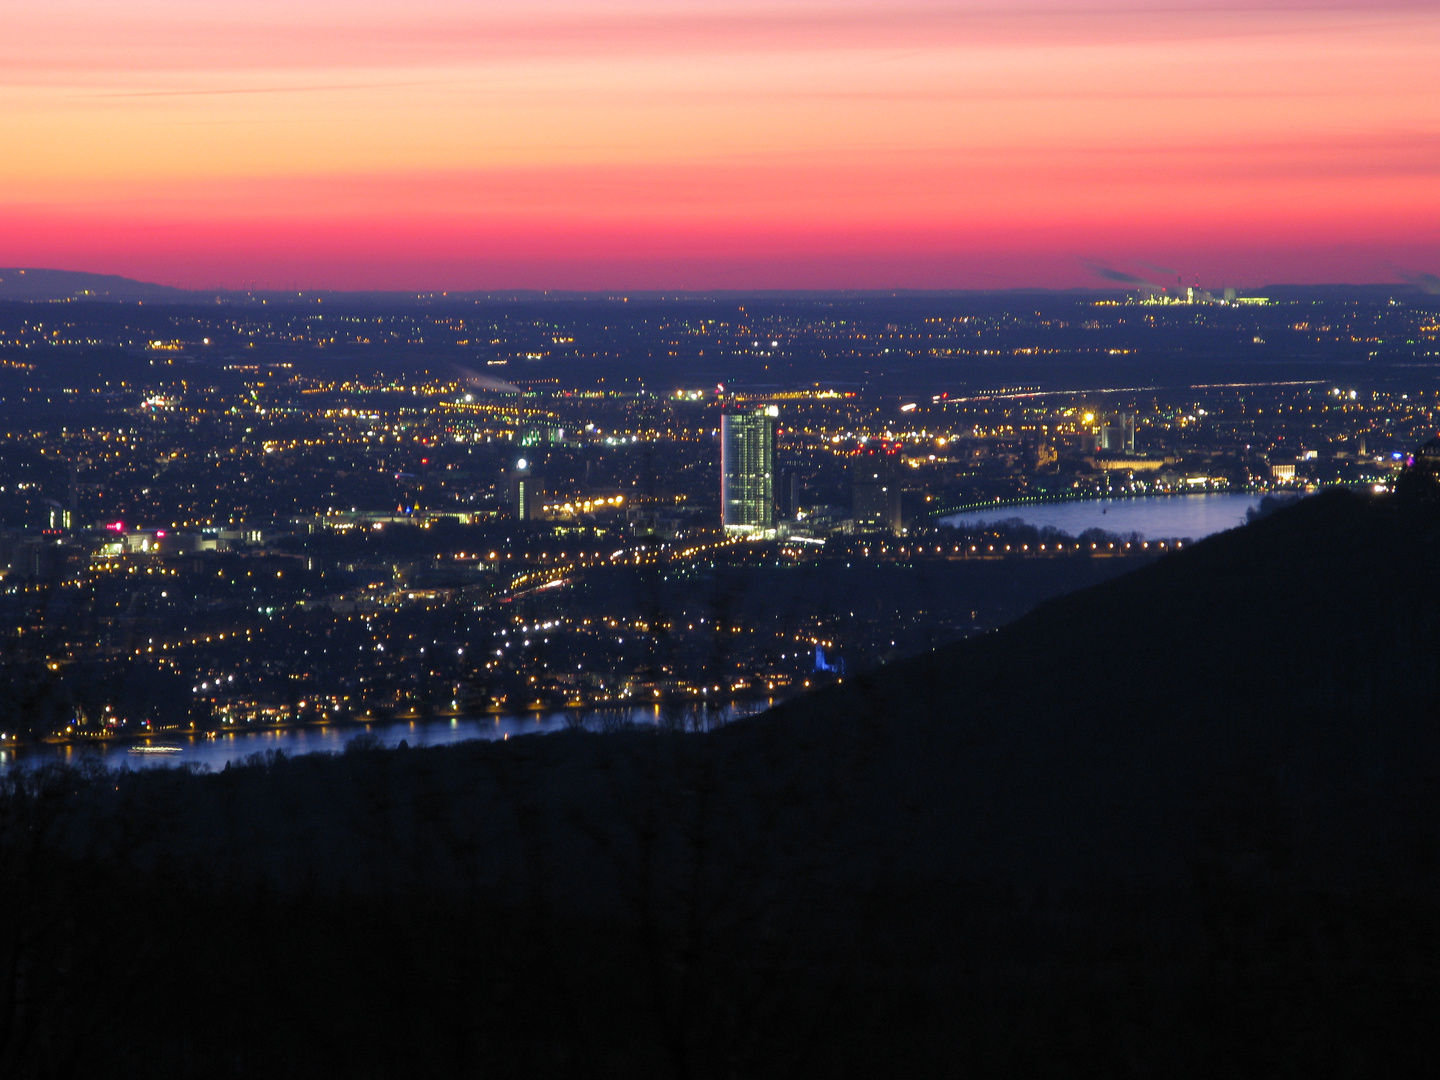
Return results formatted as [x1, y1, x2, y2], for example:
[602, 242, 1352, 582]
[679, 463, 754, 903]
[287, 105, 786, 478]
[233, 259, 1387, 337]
[0, 494, 1440, 1077]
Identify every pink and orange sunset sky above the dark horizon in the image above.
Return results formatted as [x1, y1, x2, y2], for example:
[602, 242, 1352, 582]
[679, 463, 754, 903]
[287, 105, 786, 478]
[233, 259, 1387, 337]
[0, 0, 1440, 289]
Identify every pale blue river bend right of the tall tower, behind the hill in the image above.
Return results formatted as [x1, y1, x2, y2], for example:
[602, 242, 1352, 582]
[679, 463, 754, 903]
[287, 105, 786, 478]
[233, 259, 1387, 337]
[942, 494, 1263, 540]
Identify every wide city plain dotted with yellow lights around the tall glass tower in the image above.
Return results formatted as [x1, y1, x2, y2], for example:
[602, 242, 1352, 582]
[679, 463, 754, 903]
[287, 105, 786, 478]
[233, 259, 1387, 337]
[0, 298, 1440, 754]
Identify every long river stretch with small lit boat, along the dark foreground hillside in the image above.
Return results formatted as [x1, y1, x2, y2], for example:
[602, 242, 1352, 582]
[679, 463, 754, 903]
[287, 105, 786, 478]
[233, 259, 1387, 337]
[0, 700, 773, 772]
